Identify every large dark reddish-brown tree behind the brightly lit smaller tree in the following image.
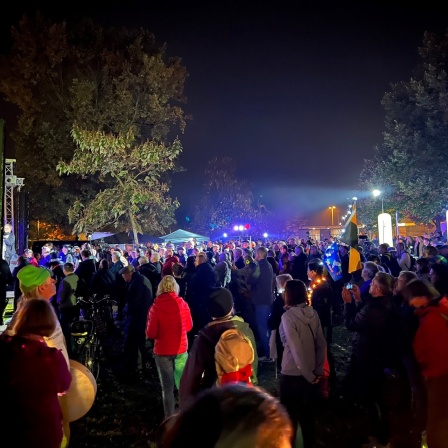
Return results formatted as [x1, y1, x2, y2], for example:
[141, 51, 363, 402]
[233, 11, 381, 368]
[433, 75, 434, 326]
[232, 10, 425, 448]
[0, 14, 187, 236]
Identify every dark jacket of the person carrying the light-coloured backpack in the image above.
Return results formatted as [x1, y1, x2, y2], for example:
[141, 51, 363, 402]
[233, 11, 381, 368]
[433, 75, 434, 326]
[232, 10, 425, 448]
[179, 316, 258, 409]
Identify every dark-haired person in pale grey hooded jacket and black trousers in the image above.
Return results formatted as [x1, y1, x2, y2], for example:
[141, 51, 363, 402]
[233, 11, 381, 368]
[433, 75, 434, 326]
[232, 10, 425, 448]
[279, 280, 327, 448]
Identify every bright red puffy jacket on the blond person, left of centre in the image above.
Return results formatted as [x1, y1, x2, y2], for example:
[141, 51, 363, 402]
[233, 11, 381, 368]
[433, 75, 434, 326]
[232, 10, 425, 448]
[146, 292, 193, 356]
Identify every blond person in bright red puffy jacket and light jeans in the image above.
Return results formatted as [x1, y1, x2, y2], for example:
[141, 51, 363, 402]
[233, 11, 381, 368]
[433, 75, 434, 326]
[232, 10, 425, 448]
[146, 275, 193, 418]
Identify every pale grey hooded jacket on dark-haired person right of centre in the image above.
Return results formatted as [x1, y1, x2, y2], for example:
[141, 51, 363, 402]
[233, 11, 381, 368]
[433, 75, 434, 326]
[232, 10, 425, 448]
[279, 303, 327, 383]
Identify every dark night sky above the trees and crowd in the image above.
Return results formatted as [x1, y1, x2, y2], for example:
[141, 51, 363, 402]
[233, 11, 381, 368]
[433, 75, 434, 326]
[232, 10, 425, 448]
[0, 0, 448, 226]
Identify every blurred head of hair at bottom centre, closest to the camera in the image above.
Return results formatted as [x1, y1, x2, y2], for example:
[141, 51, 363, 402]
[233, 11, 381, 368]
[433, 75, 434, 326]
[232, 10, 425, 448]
[159, 383, 293, 448]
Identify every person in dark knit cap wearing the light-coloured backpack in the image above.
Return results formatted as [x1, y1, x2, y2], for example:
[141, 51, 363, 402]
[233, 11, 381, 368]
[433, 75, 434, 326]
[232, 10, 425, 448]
[179, 287, 258, 410]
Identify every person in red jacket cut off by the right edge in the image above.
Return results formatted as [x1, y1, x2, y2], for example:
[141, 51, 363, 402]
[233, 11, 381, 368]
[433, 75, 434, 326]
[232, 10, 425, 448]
[402, 280, 448, 448]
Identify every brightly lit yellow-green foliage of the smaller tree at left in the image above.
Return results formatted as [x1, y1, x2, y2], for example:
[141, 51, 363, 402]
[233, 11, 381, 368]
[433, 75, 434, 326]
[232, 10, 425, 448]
[57, 126, 182, 243]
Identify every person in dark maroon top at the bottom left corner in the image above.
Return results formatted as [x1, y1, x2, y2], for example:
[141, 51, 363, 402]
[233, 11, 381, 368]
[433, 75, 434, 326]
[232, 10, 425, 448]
[0, 299, 72, 448]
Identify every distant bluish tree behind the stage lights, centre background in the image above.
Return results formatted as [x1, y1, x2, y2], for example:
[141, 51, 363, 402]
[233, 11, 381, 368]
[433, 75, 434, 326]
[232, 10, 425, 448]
[192, 157, 269, 234]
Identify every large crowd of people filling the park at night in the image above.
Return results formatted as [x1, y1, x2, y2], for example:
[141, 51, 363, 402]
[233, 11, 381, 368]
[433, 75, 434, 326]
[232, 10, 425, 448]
[1, 231, 448, 448]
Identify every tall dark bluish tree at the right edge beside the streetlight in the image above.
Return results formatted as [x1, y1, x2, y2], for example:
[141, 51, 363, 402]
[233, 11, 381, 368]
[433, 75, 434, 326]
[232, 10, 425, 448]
[359, 33, 448, 230]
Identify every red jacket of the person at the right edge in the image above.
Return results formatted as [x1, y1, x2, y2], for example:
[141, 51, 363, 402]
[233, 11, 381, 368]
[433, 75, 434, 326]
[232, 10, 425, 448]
[413, 298, 448, 378]
